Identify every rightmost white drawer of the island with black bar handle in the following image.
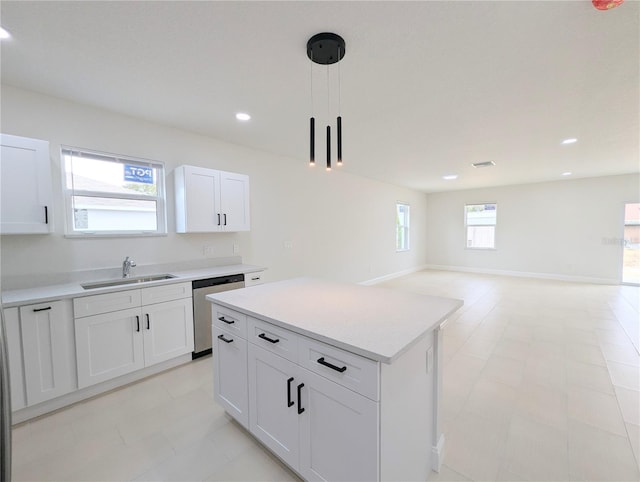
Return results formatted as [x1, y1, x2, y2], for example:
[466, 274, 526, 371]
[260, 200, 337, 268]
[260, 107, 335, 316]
[298, 336, 380, 401]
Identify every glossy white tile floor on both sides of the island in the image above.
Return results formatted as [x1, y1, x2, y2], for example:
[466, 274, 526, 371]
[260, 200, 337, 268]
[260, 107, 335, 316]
[13, 271, 640, 481]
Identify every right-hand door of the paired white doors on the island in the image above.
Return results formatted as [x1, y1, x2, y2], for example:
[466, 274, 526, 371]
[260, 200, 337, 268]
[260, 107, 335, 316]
[300, 368, 380, 481]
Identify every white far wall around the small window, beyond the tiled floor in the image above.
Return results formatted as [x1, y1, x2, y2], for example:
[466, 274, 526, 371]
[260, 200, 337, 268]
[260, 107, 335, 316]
[427, 174, 640, 283]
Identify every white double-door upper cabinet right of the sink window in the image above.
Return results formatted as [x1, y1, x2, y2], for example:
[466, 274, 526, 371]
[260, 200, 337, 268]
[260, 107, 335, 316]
[174, 166, 250, 233]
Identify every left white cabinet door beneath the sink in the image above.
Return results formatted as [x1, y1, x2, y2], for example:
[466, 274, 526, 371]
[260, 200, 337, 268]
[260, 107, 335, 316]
[75, 308, 144, 388]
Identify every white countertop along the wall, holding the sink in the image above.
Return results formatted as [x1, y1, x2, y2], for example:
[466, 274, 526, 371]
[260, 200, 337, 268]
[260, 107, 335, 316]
[2, 264, 265, 308]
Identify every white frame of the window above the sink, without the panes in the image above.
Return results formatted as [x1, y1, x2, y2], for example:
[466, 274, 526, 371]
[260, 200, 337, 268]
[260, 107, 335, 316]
[60, 145, 167, 238]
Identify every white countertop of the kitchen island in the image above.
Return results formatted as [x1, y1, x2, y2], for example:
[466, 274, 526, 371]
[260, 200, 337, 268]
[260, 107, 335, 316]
[207, 278, 463, 363]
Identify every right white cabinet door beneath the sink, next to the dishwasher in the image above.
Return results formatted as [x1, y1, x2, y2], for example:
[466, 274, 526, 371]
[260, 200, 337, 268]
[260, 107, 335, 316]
[142, 298, 193, 366]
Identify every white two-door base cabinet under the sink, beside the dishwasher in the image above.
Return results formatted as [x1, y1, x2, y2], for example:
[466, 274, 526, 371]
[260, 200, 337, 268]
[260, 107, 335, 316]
[74, 283, 193, 388]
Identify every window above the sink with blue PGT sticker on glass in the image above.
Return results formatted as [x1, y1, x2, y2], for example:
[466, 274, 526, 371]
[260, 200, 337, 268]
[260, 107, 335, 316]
[62, 147, 166, 236]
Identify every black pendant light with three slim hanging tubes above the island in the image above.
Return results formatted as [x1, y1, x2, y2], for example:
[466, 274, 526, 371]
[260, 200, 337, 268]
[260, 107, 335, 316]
[307, 32, 345, 171]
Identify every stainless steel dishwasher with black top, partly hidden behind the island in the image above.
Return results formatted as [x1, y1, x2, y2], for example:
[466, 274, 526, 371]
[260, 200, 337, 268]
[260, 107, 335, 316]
[191, 274, 244, 359]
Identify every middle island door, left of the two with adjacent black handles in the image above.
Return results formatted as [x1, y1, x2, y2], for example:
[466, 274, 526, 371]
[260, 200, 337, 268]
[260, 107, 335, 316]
[248, 343, 304, 470]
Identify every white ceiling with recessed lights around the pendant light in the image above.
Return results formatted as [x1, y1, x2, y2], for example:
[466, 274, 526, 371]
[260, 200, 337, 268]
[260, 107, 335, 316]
[0, 0, 640, 192]
